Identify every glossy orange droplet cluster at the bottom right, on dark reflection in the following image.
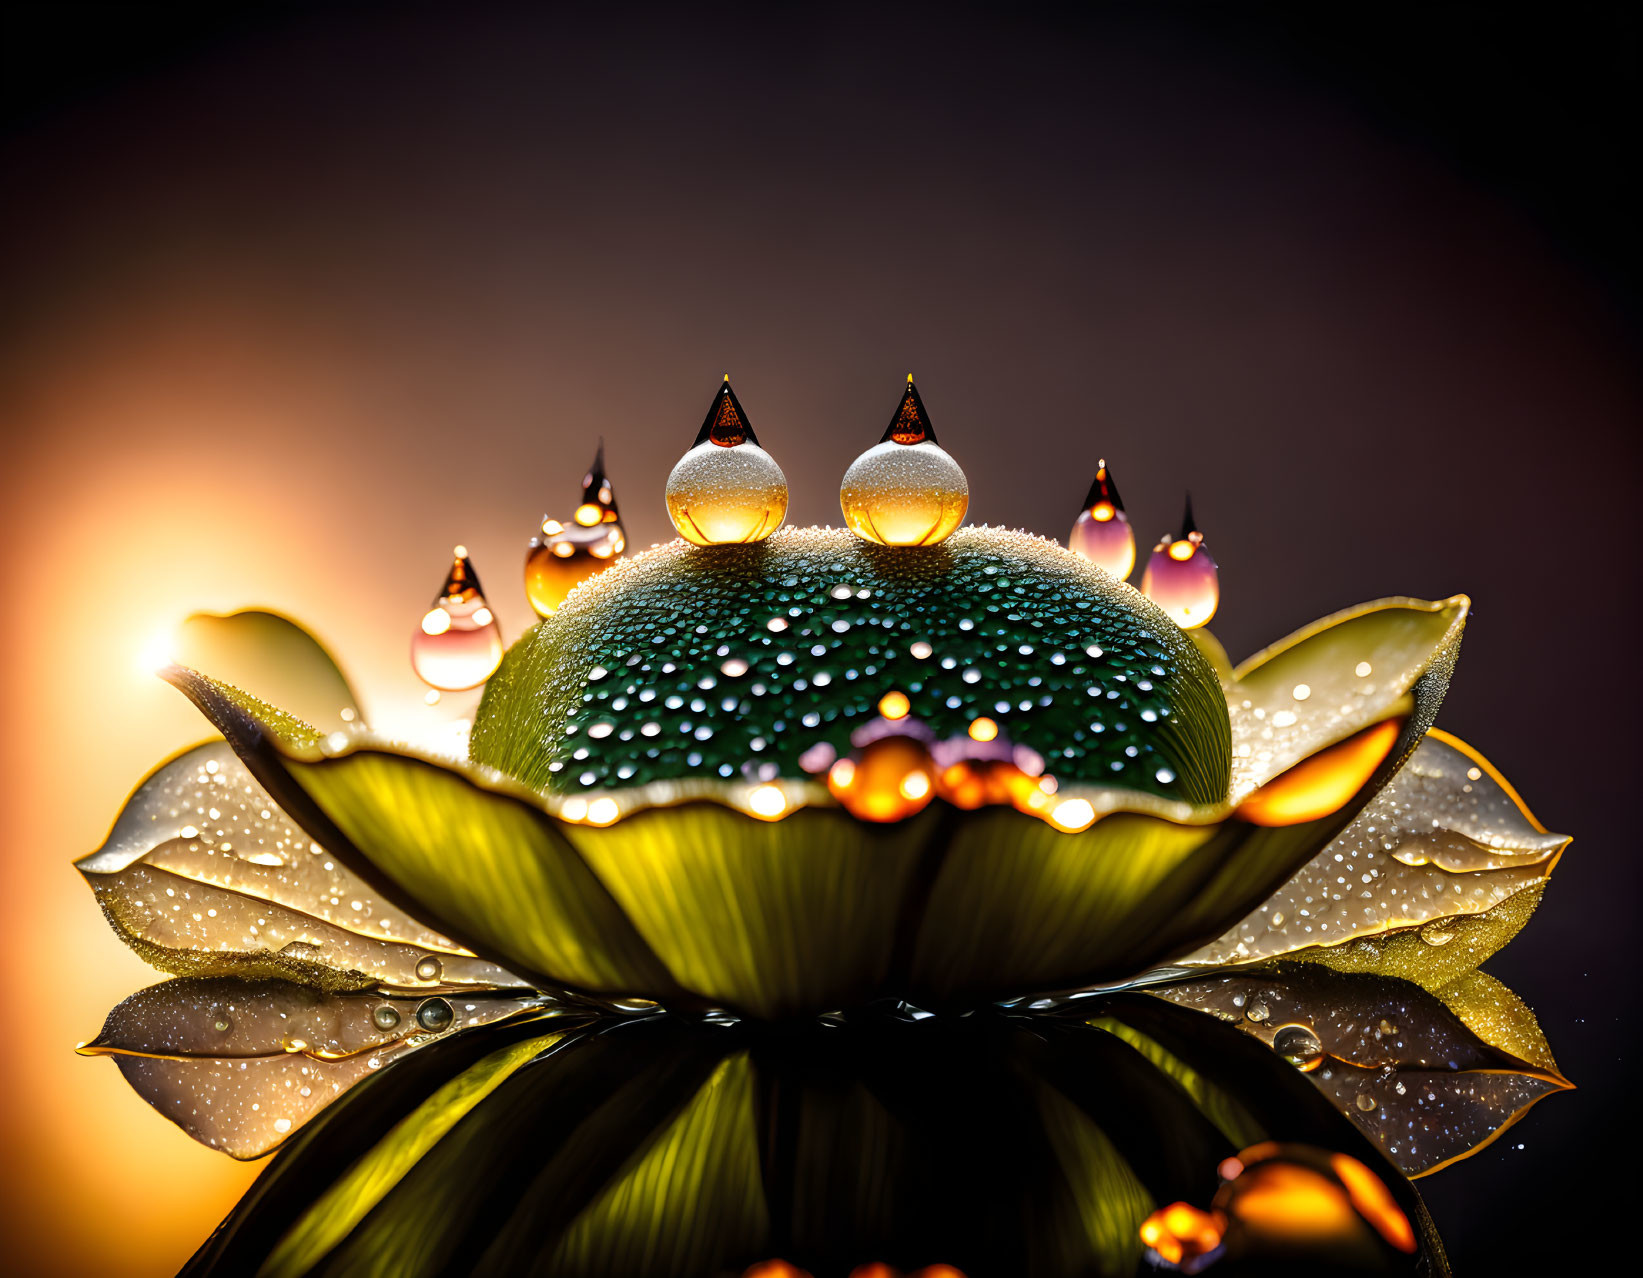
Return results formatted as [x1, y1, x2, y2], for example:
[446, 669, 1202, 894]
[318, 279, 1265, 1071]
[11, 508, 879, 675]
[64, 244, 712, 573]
[1140, 1140, 1416, 1273]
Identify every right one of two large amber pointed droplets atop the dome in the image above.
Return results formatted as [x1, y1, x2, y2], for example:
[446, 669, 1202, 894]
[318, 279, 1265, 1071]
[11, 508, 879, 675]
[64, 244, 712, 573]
[838, 373, 969, 545]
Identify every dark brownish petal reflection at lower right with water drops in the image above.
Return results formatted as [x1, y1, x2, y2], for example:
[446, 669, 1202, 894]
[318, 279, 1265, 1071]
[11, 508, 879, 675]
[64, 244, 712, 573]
[1152, 964, 1569, 1176]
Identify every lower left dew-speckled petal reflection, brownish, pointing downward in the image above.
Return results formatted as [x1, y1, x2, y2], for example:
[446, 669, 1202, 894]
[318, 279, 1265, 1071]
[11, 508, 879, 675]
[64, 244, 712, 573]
[81, 979, 555, 1158]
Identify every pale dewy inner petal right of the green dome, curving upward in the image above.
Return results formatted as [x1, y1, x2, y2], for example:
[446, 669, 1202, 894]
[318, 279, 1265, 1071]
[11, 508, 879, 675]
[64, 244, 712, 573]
[1227, 595, 1470, 803]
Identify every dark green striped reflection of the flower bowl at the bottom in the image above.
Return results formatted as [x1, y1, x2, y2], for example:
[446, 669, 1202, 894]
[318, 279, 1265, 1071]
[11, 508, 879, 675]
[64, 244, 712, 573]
[187, 997, 1444, 1278]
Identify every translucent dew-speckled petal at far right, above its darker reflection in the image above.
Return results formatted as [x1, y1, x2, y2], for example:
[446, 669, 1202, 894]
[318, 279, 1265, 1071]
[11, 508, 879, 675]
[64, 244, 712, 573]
[1178, 731, 1567, 987]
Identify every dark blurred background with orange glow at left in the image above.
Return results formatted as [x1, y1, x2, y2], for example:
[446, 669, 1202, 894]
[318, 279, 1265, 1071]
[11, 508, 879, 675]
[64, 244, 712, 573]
[0, 3, 1643, 1275]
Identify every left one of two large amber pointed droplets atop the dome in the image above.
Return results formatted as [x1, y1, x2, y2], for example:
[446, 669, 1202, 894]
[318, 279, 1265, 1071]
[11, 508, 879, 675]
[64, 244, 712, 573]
[667, 375, 787, 545]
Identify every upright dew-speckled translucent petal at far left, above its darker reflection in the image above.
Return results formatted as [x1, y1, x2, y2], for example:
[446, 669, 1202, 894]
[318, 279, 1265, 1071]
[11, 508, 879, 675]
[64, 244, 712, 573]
[77, 741, 524, 989]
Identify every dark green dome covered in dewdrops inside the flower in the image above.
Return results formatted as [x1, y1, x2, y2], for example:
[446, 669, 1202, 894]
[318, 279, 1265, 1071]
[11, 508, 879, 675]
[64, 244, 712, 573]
[472, 527, 1231, 803]
